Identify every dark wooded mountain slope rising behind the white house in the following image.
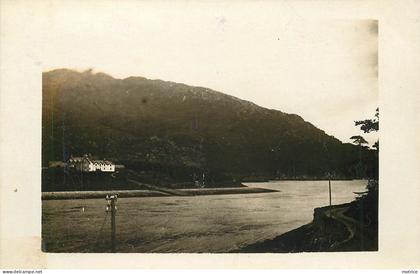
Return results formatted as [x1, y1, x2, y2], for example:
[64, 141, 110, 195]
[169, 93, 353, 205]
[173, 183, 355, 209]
[42, 69, 375, 186]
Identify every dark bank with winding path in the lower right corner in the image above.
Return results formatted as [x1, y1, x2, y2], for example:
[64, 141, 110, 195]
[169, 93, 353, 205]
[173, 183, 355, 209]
[236, 196, 378, 253]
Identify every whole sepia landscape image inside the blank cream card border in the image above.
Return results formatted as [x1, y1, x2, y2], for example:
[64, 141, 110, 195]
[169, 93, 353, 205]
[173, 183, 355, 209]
[40, 9, 380, 253]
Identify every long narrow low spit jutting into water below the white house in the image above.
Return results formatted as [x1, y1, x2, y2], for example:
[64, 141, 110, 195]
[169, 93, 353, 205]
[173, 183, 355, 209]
[41, 187, 279, 200]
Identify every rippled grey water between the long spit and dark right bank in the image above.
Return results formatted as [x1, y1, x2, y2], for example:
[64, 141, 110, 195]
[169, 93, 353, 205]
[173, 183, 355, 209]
[42, 180, 367, 252]
